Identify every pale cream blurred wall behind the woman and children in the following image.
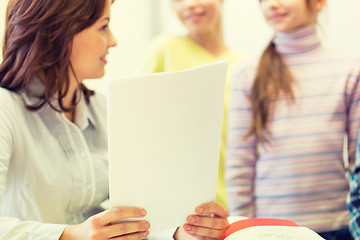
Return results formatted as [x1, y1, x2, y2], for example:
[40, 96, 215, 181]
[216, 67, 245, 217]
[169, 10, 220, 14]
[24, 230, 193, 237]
[0, 0, 360, 93]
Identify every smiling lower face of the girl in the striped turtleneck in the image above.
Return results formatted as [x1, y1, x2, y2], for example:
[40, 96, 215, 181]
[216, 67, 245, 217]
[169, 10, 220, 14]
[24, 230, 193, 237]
[260, 0, 325, 33]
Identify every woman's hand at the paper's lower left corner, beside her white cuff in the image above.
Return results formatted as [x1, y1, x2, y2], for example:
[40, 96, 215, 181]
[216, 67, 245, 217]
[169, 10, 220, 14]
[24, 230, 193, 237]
[59, 207, 150, 240]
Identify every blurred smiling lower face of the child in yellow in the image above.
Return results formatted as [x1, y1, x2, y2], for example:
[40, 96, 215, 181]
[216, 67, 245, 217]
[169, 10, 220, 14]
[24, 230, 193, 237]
[171, 0, 223, 35]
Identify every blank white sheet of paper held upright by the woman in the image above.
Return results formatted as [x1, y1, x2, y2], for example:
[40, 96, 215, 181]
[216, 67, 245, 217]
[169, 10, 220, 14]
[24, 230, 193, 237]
[108, 61, 227, 233]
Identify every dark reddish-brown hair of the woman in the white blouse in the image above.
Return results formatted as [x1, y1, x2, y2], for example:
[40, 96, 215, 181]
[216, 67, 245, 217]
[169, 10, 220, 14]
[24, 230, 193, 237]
[0, 0, 111, 111]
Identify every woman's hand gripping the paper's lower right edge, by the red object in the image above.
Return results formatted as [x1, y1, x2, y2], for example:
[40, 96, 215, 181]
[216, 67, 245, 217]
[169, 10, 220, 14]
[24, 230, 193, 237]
[175, 202, 229, 240]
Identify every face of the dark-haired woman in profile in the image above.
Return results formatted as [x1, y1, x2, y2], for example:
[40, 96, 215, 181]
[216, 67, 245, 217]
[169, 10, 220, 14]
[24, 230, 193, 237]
[70, 1, 117, 81]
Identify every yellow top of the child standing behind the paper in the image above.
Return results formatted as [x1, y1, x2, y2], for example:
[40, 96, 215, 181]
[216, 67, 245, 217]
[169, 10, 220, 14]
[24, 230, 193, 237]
[138, 35, 242, 208]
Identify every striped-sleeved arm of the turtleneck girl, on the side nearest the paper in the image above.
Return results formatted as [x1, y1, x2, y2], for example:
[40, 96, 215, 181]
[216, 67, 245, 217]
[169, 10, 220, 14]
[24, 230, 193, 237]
[225, 66, 257, 217]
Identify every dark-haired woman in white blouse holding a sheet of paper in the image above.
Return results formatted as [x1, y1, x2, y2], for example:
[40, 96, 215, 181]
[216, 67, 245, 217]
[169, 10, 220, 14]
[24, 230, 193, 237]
[0, 0, 227, 240]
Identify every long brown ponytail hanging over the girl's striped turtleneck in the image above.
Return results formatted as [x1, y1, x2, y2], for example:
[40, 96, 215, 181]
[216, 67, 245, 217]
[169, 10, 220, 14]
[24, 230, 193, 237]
[246, 0, 313, 142]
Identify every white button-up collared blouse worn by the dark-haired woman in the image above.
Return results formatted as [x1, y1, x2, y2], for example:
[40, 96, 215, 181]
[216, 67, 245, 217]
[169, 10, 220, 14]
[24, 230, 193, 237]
[0, 81, 109, 240]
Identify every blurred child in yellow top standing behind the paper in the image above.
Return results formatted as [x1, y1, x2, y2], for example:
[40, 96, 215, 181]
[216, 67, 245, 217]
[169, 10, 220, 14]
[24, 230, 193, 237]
[140, 0, 241, 207]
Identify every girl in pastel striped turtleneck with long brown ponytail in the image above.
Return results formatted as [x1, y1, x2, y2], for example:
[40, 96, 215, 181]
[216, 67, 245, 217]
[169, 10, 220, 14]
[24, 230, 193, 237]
[225, 0, 360, 240]
